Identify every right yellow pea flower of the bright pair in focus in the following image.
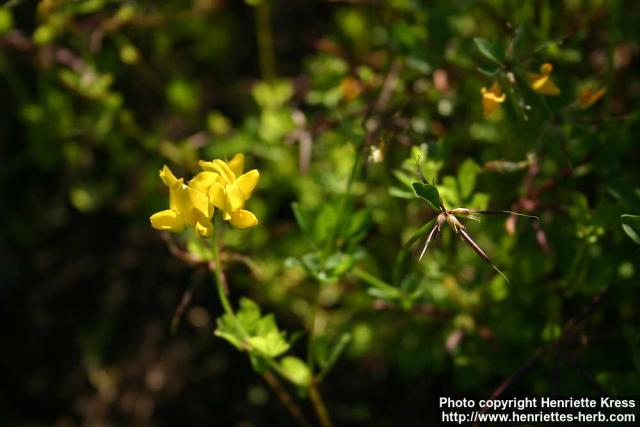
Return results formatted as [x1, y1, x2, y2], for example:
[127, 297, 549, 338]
[199, 154, 260, 228]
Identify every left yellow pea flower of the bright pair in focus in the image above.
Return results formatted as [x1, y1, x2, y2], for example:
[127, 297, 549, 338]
[149, 165, 214, 237]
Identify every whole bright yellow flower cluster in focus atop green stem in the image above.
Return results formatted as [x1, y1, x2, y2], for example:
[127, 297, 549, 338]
[150, 154, 260, 237]
